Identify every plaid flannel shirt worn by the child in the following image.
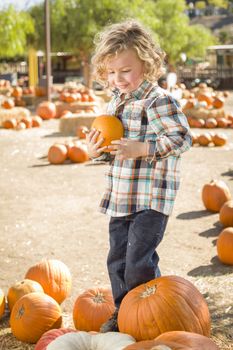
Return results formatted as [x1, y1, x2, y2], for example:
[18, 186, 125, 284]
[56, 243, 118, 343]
[100, 81, 192, 216]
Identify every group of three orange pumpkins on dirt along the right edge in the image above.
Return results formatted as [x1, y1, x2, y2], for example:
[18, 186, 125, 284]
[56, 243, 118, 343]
[202, 180, 233, 265]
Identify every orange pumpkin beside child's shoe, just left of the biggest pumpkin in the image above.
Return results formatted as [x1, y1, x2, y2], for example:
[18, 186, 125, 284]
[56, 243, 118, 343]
[73, 288, 115, 332]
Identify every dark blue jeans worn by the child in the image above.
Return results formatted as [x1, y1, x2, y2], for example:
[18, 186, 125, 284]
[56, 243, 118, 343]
[107, 209, 168, 308]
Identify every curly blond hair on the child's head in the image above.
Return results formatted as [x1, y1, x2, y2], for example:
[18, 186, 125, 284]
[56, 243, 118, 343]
[92, 20, 165, 86]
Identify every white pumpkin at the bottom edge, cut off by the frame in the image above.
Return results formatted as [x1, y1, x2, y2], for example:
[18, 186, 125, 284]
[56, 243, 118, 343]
[47, 331, 135, 350]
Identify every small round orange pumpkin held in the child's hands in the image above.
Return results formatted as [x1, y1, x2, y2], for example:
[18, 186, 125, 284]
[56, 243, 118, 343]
[91, 115, 124, 147]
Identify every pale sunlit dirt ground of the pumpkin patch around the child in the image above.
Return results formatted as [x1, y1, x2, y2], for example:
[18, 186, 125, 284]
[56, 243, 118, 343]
[0, 92, 233, 350]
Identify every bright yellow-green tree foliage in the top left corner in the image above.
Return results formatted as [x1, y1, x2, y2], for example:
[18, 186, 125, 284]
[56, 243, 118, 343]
[0, 5, 34, 57]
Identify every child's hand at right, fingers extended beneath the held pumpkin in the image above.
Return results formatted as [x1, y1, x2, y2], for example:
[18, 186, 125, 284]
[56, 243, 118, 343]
[108, 138, 148, 160]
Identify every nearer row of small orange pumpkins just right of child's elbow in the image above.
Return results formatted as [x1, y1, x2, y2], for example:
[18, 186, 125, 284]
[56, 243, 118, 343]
[192, 132, 228, 147]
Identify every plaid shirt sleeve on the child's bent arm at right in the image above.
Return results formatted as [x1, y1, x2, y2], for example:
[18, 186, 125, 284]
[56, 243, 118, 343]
[147, 95, 192, 162]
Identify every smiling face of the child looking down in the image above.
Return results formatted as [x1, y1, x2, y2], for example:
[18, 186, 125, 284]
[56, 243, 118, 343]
[106, 49, 143, 93]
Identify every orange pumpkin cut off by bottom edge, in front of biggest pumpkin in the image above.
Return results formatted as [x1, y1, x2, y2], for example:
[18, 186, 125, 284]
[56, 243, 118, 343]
[124, 331, 219, 350]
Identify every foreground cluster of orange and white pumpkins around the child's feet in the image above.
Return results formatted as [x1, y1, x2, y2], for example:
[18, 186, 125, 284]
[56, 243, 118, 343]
[0, 259, 218, 350]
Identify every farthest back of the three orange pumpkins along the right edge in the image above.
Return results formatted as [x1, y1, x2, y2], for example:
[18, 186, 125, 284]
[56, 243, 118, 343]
[202, 180, 231, 212]
